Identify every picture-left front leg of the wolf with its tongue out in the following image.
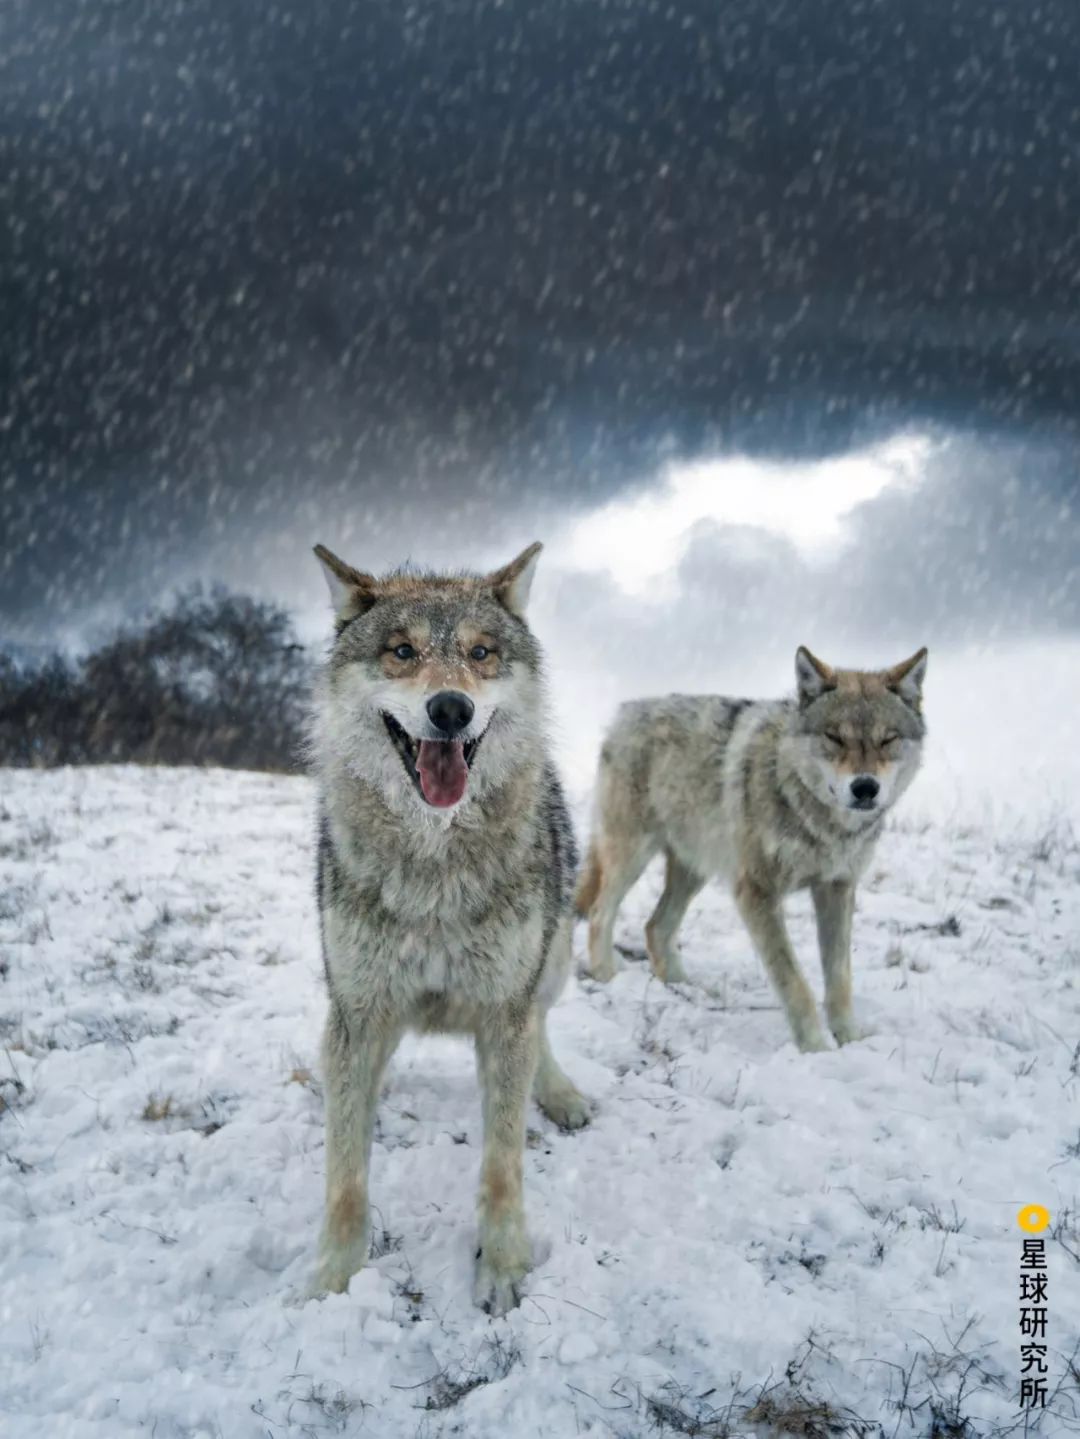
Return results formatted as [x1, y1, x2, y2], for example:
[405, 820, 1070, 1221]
[316, 1000, 400, 1294]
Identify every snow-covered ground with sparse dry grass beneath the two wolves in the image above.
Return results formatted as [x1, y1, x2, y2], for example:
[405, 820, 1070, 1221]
[0, 770, 1080, 1439]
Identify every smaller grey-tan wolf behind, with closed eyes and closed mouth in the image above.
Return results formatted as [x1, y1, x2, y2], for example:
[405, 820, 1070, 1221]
[577, 646, 928, 1050]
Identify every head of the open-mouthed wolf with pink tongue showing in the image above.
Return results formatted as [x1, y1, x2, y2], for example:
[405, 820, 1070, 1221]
[315, 544, 544, 817]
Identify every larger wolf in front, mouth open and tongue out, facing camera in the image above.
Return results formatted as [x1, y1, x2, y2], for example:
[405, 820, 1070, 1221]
[312, 544, 588, 1314]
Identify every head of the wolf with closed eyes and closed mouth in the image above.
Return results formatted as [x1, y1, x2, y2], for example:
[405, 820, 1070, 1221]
[794, 646, 926, 812]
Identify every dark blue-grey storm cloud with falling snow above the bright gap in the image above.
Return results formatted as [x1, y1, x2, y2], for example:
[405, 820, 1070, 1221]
[0, 0, 1080, 636]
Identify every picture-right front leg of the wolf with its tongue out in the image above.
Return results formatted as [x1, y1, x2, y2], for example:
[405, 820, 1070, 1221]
[473, 1006, 539, 1314]
